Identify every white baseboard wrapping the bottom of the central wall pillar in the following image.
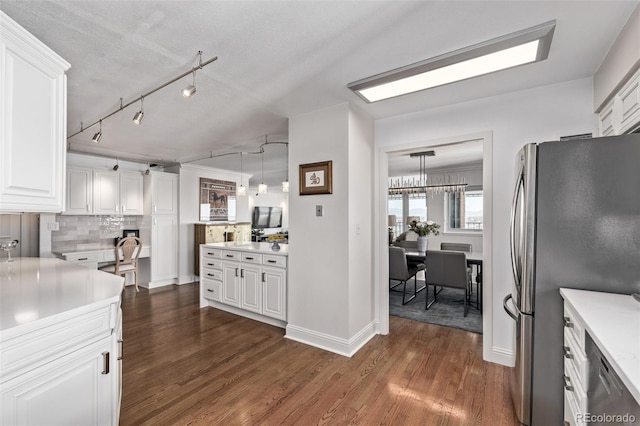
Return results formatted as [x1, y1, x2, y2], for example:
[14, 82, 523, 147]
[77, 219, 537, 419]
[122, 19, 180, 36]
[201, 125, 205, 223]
[284, 322, 376, 358]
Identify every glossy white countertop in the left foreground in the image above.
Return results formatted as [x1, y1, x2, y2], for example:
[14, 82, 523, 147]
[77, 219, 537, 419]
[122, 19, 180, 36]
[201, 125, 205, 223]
[0, 257, 124, 333]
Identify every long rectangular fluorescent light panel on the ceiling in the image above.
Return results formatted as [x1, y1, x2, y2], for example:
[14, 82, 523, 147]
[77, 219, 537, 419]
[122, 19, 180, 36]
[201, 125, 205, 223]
[347, 21, 555, 103]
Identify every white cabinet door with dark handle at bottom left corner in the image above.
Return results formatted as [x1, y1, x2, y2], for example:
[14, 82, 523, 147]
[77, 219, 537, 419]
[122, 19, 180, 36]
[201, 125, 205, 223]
[0, 337, 115, 425]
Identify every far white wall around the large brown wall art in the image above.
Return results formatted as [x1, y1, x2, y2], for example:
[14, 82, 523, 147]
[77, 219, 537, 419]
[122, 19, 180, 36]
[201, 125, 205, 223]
[169, 164, 251, 284]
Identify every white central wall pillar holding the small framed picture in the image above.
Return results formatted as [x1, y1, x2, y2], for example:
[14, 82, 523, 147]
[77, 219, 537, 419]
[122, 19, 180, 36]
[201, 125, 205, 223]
[287, 103, 374, 355]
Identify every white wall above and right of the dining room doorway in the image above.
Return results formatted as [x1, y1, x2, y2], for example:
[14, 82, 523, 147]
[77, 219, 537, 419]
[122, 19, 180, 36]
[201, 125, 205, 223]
[376, 78, 597, 364]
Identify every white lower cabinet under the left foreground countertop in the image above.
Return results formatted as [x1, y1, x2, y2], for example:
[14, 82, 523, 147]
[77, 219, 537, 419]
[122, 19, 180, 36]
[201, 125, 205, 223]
[0, 305, 122, 425]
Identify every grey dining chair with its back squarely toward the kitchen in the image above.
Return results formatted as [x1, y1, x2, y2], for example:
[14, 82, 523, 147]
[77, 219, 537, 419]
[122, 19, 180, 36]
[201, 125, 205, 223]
[425, 250, 469, 317]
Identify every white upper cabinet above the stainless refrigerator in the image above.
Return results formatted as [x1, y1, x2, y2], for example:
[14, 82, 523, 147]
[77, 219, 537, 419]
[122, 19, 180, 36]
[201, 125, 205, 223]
[598, 69, 640, 136]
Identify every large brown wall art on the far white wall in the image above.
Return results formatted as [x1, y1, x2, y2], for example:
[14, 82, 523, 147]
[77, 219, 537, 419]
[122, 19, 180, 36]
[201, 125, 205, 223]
[199, 178, 236, 222]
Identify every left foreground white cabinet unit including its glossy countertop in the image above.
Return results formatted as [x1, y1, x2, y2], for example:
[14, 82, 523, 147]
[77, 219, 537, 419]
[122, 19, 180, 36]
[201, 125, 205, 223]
[0, 258, 124, 425]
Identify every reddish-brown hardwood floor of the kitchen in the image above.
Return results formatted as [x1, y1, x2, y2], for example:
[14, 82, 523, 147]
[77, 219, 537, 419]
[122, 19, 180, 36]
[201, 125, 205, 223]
[120, 283, 517, 425]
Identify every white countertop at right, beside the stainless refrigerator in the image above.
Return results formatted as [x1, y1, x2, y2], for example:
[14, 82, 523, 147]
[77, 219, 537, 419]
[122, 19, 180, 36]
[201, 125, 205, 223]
[560, 288, 640, 404]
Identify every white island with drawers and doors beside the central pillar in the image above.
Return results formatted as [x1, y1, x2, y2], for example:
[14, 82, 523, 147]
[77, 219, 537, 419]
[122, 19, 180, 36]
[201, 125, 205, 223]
[200, 242, 289, 328]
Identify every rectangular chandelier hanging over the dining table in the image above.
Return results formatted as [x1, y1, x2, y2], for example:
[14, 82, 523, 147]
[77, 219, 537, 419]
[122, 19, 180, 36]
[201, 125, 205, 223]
[389, 151, 467, 195]
